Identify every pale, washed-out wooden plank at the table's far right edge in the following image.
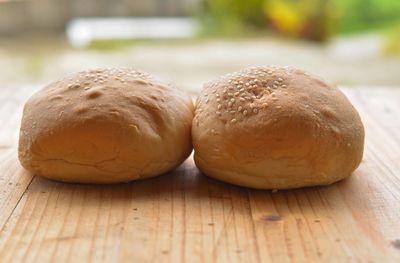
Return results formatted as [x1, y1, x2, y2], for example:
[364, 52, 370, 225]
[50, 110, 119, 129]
[347, 88, 400, 255]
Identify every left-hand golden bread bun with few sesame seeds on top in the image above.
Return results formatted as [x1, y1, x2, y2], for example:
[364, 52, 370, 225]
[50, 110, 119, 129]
[19, 69, 194, 183]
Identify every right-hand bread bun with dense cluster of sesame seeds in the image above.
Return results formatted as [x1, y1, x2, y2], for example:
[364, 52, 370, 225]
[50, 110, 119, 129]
[192, 67, 364, 189]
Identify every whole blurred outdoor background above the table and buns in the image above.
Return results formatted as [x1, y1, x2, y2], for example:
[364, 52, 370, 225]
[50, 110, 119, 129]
[0, 0, 400, 92]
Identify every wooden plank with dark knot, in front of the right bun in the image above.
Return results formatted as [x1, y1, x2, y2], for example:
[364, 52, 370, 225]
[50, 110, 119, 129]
[250, 185, 394, 262]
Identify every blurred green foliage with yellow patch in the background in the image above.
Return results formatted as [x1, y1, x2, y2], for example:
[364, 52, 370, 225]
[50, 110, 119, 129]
[199, 0, 400, 41]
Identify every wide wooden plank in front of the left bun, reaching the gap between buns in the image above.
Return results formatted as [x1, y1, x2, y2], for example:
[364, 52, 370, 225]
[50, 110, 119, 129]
[0, 160, 258, 262]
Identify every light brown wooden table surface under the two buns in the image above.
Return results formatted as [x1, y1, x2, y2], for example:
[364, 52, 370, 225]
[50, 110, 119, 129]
[0, 87, 400, 263]
